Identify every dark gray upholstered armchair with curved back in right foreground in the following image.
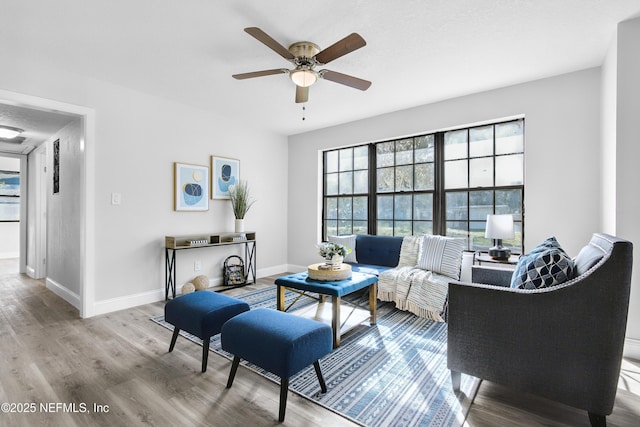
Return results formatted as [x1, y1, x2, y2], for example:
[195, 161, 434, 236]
[447, 234, 633, 425]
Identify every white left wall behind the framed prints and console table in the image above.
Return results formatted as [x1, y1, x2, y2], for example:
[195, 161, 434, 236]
[0, 58, 288, 315]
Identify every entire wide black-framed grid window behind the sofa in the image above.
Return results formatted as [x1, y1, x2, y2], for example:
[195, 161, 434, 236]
[323, 119, 524, 252]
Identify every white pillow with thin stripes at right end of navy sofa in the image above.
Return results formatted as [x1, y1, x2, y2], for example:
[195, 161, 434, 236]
[418, 234, 465, 280]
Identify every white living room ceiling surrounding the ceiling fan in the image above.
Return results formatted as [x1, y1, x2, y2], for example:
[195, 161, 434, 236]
[0, 0, 640, 140]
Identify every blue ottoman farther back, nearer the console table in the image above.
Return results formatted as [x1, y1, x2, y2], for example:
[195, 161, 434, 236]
[164, 291, 249, 372]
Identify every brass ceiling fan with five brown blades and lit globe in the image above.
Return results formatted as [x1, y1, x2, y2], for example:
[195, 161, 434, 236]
[233, 27, 371, 103]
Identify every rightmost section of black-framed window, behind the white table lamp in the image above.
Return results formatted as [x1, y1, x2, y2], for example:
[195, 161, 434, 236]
[441, 120, 524, 251]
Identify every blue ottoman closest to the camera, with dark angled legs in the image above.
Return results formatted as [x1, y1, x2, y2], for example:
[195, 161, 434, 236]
[221, 308, 333, 422]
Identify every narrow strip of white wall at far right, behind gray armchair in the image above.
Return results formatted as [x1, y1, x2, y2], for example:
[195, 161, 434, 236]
[615, 18, 640, 359]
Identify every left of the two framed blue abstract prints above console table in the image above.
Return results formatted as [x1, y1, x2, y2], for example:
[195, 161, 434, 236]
[173, 162, 209, 211]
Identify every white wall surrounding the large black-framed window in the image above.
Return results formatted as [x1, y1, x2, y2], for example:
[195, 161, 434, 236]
[288, 68, 601, 266]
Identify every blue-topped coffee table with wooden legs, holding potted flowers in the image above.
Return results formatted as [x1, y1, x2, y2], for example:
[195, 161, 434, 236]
[275, 272, 378, 348]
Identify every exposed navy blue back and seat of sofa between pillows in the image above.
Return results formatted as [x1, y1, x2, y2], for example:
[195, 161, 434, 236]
[349, 234, 403, 276]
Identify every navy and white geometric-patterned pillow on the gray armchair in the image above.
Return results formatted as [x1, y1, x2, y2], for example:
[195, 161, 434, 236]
[511, 237, 574, 289]
